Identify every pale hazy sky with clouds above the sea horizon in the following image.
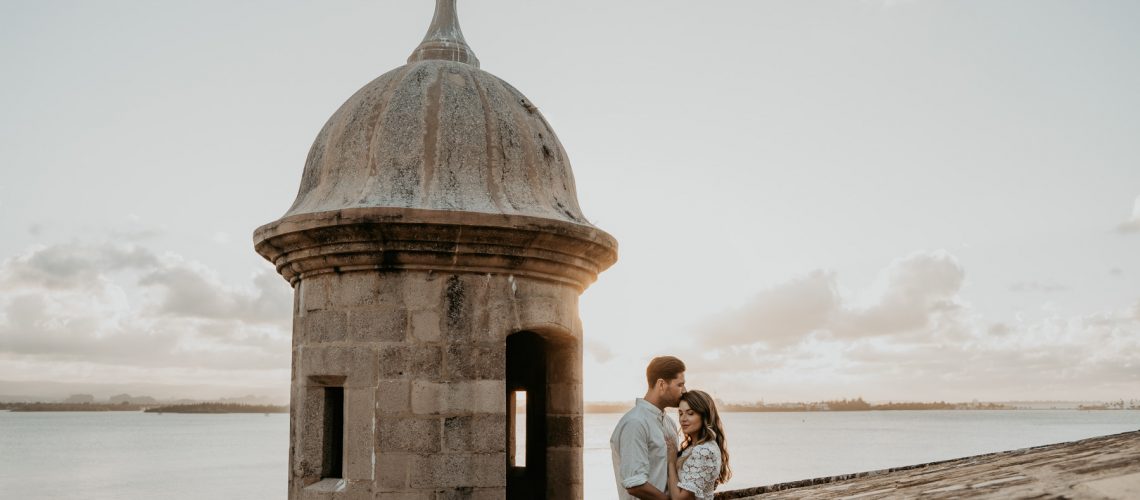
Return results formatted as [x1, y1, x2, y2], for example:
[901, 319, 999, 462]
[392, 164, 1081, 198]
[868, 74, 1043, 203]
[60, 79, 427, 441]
[0, 0, 1140, 402]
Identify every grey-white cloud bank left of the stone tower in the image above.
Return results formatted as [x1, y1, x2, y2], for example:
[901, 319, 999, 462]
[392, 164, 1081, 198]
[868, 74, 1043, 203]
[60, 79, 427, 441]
[0, 241, 292, 382]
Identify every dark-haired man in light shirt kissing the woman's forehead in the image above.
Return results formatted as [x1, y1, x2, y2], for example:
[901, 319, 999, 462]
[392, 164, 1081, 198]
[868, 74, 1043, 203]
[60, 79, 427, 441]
[610, 355, 685, 500]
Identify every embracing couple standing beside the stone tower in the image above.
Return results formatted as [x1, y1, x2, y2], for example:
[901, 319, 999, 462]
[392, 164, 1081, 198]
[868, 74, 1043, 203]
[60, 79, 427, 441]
[610, 355, 732, 500]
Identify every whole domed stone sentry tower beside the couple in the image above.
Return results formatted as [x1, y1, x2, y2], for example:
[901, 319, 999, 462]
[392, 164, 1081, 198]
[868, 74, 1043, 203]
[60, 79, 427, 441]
[254, 0, 617, 499]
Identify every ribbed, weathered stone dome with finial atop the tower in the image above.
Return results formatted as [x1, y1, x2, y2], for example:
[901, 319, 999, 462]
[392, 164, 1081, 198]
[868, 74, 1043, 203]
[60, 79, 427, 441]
[285, 0, 589, 226]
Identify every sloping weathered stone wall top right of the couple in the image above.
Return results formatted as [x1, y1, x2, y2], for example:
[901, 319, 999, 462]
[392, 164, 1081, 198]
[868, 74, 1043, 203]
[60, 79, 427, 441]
[716, 431, 1140, 500]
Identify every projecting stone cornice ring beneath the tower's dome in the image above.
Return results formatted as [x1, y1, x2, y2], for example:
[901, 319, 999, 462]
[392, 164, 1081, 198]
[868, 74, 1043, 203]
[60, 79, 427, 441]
[253, 207, 618, 290]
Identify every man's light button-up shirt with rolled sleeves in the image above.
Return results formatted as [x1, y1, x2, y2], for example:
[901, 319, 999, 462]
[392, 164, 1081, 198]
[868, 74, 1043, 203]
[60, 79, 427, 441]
[610, 397, 677, 500]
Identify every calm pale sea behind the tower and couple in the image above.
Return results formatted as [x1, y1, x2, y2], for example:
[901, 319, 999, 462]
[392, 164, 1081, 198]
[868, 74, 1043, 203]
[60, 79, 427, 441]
[0, 410, 1140, 500]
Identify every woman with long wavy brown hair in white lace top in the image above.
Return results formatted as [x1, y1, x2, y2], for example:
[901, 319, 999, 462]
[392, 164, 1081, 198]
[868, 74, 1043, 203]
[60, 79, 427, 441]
[666, 391, 732, 500]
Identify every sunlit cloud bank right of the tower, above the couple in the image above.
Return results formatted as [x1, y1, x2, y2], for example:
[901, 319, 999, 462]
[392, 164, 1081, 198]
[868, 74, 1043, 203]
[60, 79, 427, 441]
[685, 252, 1140, 401]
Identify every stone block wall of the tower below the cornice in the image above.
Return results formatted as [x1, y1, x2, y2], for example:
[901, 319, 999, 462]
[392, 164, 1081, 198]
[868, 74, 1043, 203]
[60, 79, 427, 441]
[290, 270, 583, 500]
